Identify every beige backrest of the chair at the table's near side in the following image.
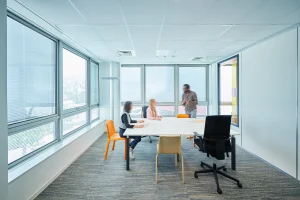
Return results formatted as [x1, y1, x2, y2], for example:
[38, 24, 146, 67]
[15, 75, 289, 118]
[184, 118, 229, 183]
[157, 136, 181, 154]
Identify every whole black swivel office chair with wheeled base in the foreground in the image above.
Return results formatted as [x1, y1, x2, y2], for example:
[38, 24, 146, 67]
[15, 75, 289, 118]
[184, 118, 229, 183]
[194, 115, 243, 194]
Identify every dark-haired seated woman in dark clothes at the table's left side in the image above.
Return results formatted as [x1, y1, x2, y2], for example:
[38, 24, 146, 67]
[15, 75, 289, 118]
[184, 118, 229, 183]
[119, 101, 144, 160]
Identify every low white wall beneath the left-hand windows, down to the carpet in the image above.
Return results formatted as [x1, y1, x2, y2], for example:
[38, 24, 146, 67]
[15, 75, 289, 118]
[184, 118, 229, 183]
[8, 122, 105, 200]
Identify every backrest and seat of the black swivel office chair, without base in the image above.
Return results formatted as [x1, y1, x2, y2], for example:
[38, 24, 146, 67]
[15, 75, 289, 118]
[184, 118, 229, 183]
[204, 115, 231, 160]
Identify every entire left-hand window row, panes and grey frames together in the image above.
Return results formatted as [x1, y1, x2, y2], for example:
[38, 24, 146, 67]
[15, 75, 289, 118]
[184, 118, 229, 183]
[7, 12, 99, 168]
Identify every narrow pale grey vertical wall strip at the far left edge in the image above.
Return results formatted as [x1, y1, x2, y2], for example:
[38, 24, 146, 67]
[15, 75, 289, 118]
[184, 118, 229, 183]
[0, 0, 8, 200]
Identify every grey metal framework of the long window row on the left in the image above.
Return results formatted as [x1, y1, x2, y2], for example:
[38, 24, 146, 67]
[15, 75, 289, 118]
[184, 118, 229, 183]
[7, 11, 100, 169]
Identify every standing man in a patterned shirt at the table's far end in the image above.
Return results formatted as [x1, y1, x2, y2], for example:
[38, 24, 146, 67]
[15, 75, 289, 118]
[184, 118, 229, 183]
[182, 84, 198, 118]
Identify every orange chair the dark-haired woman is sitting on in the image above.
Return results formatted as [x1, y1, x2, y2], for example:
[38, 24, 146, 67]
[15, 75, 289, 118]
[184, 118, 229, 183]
[104, 120, 127, 160]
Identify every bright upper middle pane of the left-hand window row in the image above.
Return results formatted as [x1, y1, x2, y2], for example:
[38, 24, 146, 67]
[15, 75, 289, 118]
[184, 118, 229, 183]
[63, 49, 87, 110]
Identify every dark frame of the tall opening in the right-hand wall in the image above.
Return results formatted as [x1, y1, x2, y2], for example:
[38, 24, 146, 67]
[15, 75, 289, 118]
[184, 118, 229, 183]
[217, 54, 240, 127]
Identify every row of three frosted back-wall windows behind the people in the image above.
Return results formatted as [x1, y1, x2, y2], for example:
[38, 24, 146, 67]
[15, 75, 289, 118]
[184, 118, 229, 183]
[120, 65, 208, 117]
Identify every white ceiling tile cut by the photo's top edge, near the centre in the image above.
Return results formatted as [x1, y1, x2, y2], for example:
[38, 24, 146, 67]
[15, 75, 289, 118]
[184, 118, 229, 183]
[121, 0, 167, 25]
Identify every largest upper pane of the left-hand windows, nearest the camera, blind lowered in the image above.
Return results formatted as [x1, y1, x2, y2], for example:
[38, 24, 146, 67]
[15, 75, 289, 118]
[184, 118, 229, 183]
[7, 18, 56, 123]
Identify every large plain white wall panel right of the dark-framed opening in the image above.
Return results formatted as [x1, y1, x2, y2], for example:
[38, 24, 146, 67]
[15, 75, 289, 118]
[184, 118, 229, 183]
[241, 29, 297, 177]
